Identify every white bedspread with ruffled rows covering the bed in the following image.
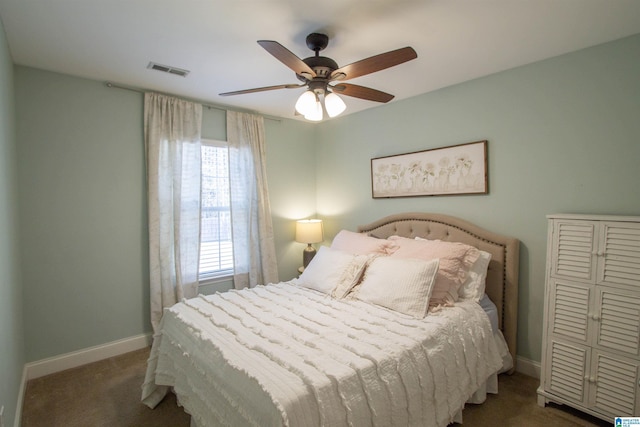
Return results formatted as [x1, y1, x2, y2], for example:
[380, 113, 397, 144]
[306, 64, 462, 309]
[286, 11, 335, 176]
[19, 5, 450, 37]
[142, 282, 502, 427]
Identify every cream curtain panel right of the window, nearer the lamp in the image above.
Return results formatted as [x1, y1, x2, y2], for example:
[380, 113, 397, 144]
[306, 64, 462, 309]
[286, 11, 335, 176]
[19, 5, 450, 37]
[227, 111, 278, 289]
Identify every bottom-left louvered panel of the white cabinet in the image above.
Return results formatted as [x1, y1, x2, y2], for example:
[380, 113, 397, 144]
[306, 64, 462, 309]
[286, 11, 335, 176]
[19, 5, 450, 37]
[545, 339, 590, 405]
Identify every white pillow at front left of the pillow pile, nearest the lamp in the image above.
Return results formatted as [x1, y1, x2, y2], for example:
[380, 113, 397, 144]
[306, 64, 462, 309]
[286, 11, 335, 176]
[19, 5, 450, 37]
[298, 246, 369, 298]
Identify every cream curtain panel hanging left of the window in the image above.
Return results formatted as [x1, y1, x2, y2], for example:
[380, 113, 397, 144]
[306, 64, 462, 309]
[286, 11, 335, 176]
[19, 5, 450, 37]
[144, 93, 202, 331]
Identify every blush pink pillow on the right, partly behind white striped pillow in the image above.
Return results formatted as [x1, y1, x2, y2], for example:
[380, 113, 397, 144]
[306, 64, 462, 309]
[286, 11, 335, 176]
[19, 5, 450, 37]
[389, 236, 480, 307]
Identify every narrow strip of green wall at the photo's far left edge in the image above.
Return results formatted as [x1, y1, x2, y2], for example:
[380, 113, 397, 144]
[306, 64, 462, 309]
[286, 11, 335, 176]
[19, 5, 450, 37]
[0, 15, 25, 425]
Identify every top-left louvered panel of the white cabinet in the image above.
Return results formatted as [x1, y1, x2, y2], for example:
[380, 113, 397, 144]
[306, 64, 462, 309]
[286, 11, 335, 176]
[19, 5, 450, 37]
[550, 221, 598, 283]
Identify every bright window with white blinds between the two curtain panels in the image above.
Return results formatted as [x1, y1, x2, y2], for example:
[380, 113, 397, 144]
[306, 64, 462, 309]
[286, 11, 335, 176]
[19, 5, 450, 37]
[198, 140, 233, 281]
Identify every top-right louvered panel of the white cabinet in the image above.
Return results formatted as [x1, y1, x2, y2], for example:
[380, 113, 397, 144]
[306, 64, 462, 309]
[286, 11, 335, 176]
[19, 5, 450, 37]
[596, 222, 640, 291]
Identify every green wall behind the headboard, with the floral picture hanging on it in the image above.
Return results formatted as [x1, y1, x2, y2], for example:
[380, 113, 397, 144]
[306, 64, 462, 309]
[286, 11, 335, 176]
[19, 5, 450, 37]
[316, 35, 640, 361]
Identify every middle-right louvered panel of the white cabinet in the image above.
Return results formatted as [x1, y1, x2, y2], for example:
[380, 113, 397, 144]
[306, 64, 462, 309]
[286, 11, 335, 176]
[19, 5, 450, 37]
[594, 286, 640, 357]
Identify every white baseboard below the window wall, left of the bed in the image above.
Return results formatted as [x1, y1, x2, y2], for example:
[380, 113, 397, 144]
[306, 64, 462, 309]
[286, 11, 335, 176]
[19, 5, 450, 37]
[24, 334, 151, 381]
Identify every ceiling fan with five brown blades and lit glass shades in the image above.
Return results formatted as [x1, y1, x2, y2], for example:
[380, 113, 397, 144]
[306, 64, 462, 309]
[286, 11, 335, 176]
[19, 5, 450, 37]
[220, 33, 418, 121]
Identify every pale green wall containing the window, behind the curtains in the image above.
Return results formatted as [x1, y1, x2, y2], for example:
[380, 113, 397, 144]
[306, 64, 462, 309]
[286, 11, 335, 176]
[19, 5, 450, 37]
[15, 66, 315, 361]
